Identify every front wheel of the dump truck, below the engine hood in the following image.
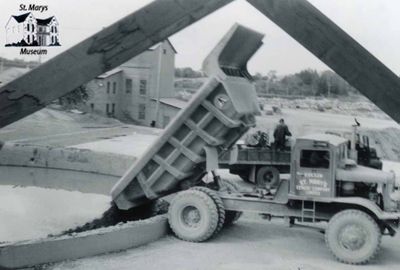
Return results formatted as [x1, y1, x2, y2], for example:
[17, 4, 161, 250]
[325, 210, 382, 264]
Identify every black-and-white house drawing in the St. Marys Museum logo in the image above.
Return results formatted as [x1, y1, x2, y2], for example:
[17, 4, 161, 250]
[6, 12, 60, 46]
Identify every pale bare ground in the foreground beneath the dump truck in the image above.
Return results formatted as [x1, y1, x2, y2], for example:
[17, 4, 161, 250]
[49, 215, 400, 270]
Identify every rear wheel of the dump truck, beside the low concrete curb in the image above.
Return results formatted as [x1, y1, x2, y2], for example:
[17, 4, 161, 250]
[168, 190, 219, 242]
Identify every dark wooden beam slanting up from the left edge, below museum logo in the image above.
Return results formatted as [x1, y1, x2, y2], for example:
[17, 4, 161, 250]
[0, 0, 232, 128]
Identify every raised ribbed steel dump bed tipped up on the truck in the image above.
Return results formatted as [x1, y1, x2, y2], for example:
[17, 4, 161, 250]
[111, 25, 263, 209]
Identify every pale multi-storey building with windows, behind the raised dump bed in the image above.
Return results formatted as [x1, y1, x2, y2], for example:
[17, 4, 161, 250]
[86, 40, 185, 128]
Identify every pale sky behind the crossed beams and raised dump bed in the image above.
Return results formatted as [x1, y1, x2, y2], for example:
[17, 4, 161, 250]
[0, 0, 400, 75]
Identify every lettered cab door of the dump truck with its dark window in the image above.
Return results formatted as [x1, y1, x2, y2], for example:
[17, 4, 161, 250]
[292, 149, 334, 198]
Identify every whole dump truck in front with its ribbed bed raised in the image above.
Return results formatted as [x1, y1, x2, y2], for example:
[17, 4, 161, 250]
[111, 25, 400, 264]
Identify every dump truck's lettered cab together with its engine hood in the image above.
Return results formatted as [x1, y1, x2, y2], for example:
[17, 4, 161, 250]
[288, 134, 398, 212]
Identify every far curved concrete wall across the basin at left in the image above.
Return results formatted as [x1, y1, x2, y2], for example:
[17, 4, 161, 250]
[0, 143, 135, 195]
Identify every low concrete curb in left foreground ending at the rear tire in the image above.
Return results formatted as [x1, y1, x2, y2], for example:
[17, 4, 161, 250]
[0, 216, 168, 269]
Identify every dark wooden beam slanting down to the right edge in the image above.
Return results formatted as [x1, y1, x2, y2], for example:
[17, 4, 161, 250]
[247, 0, 400, 122]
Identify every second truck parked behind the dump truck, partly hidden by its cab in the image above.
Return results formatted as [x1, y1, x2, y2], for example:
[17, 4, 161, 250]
[219, 122, 383, 189]
